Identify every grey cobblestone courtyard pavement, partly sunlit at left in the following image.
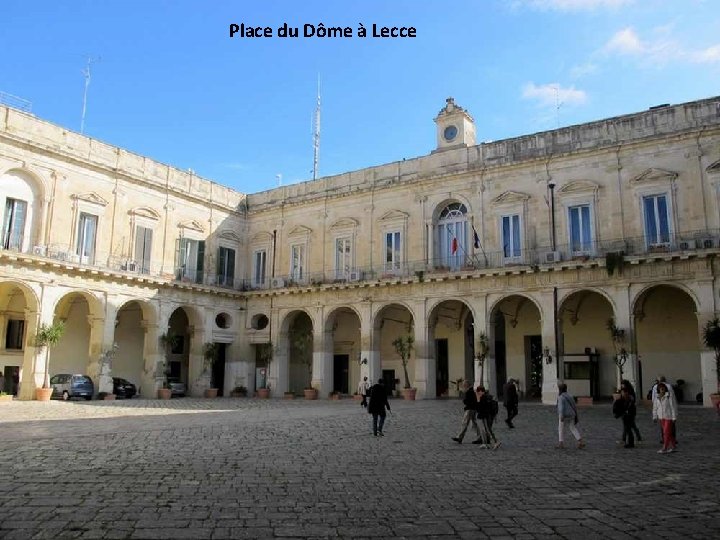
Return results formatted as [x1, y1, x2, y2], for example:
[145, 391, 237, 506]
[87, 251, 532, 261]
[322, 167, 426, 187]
[0, 398, 720, 540]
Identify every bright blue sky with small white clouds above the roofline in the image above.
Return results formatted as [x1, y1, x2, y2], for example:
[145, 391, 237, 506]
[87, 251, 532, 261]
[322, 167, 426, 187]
[0, 0, 720, 193]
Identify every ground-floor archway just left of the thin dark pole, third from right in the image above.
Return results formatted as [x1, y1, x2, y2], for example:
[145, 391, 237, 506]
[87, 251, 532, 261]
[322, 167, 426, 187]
[490, 295, 543, 399]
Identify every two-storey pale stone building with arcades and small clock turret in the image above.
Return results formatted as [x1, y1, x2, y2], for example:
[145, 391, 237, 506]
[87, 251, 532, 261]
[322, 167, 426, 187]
[0, 97, 720, 404]
